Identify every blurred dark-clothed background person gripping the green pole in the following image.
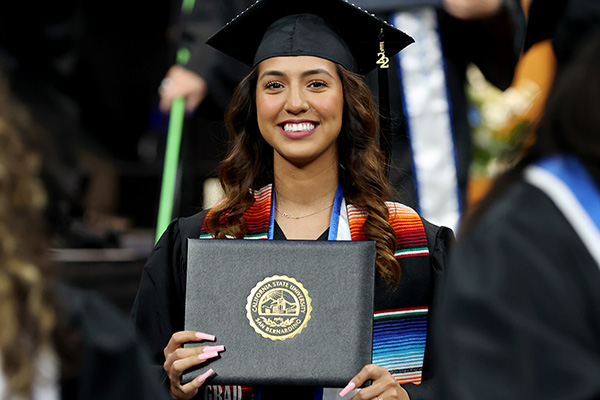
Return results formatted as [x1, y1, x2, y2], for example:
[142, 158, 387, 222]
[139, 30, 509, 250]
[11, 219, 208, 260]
[159, 0, 254, 215]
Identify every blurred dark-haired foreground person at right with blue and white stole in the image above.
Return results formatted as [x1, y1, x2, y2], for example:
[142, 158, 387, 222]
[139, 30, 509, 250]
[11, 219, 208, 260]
[434, 21, 600, 400]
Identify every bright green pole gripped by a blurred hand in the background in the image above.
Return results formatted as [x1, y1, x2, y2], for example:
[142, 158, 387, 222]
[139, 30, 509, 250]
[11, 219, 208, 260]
[155, 0, 195, 242]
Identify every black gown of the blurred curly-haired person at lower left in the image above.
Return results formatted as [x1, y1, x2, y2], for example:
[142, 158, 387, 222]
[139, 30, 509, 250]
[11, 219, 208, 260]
[56, 285, 170, 400]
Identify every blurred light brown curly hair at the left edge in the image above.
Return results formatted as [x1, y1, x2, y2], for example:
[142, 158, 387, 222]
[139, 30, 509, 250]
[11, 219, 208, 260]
[0, 82, 57, 398]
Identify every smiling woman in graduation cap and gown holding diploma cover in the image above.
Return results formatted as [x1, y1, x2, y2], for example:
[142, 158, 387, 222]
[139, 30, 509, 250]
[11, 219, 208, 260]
[132, 0, 452, 400]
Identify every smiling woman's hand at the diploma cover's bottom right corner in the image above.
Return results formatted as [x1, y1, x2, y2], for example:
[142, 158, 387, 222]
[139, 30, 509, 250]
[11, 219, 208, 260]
[340, 364, 410, 400]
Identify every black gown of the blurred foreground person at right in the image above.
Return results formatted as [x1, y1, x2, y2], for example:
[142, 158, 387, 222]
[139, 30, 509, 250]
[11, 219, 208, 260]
[434, 183, 600, 400]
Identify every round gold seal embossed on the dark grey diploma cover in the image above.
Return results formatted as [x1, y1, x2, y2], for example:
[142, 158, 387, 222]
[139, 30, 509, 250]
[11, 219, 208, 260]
[246, 275, 312, 340]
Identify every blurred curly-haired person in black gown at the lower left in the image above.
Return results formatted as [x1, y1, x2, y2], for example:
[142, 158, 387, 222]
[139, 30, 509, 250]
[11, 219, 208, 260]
[0, 76, 168, 400]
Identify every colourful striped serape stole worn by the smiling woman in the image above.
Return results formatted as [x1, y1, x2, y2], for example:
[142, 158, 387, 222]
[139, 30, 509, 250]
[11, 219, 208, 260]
[200, 185, 429, 384]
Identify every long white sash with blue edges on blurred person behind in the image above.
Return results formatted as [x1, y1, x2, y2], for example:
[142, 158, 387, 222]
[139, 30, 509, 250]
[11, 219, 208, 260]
[391, 7, 461, 230]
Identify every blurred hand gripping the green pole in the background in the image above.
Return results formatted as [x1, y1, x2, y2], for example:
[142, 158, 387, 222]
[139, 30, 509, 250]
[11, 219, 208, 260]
[158, 65, 208, 112]
